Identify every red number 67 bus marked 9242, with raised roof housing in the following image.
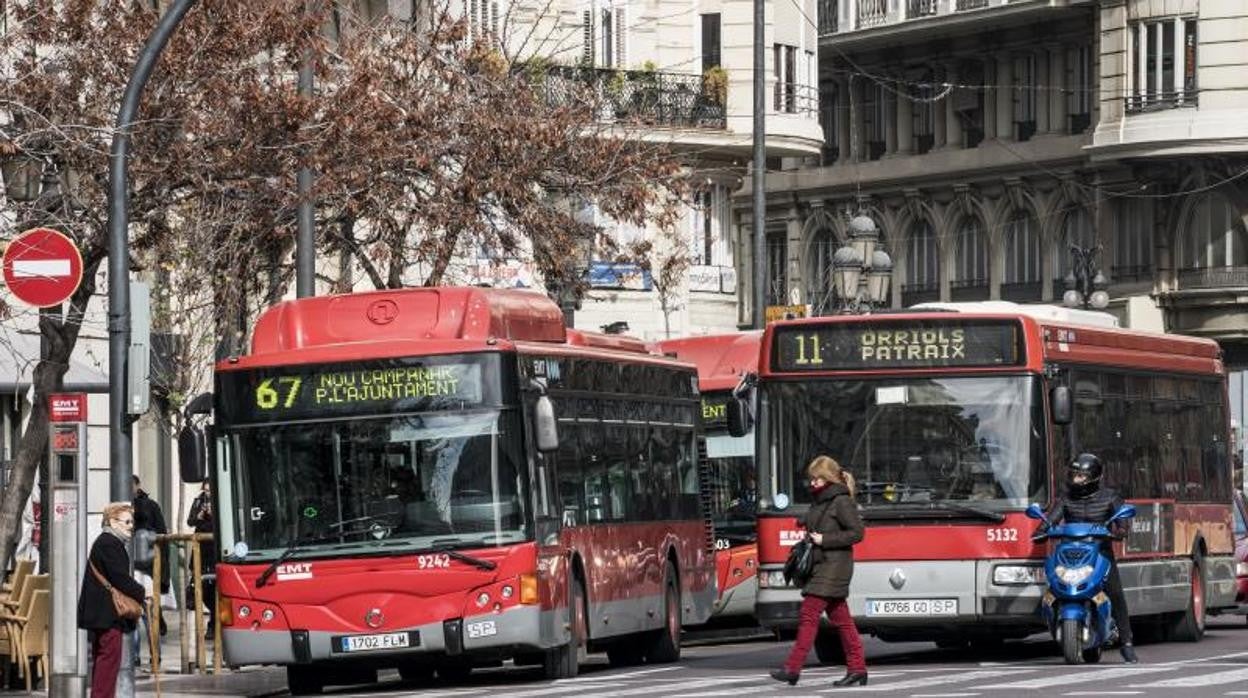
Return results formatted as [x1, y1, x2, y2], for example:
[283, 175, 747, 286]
[187, 287, 715, 694]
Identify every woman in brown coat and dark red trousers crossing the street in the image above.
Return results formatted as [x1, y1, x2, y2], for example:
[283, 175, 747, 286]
[771, 456, 866, 687]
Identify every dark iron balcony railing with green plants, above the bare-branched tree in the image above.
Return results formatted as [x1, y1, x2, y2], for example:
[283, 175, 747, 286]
[534, 66, 728, 129]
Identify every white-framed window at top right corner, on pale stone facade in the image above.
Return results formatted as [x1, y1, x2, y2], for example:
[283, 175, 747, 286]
[1127, 17, 1197, 112]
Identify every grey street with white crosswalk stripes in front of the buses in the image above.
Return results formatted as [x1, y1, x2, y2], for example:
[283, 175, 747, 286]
[129, 617, 1248, 698]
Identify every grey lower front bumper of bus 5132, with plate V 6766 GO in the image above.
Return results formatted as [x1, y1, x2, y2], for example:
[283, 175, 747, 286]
[754, 559, 1045, 641]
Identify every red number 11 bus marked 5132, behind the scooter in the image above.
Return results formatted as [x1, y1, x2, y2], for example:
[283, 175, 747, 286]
[731, 303, 1236, 662]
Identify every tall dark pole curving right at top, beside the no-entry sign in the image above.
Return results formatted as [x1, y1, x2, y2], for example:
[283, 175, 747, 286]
[109, 0, 195, 698]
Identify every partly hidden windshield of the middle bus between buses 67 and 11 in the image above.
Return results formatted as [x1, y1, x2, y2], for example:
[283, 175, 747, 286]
[703, 433, 758, 543]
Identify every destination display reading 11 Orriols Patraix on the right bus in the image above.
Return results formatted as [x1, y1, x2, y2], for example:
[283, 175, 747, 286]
[771, 320, 1023, 371]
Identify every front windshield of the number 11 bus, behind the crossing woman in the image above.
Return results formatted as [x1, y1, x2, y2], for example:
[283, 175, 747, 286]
[766, 376, 1047, 513]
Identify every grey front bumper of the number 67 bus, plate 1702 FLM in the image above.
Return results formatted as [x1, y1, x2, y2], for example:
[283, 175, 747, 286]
[221, 606, 543, 666]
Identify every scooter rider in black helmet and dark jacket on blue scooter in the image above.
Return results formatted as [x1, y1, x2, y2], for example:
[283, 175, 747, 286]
[1043, 453, 1139, 664]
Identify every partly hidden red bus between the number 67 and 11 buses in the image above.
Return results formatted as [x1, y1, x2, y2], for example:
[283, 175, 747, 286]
[656, 332, 763, 619]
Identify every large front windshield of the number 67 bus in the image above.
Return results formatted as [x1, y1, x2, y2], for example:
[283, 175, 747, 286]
[225, 410, 529, 557]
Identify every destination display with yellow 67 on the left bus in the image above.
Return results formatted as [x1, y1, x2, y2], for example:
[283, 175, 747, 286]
[220, 362, 482, 422]
